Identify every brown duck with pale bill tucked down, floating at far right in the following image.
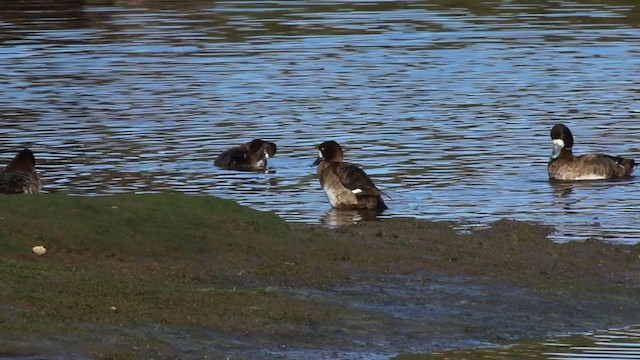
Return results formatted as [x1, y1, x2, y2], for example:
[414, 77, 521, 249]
[547, 124, 638, 180]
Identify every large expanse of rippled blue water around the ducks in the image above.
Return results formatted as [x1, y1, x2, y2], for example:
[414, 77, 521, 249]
[0, 0, 640, 243]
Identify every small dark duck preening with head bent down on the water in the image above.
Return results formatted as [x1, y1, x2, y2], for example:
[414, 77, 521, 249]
[214, 139, 278, 170]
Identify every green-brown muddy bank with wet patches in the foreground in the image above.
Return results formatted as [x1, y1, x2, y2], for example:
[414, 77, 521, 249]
[0, 194, 640, 359]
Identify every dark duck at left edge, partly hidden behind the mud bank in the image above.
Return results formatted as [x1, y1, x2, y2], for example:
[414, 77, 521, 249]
[0, 149, 42, 194]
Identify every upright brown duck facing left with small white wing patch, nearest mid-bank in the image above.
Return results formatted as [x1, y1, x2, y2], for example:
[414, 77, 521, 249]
[312, 141, 387, 210]
